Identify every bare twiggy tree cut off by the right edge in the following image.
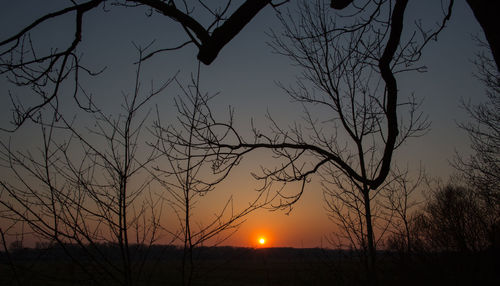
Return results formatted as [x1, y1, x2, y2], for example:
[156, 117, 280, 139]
[453, 38, 500, 250]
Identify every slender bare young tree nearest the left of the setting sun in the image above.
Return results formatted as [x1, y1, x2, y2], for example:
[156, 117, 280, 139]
[152, 68, 269, 285]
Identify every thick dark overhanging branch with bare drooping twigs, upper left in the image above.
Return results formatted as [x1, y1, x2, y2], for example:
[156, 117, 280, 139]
[0, 0, 276, 130]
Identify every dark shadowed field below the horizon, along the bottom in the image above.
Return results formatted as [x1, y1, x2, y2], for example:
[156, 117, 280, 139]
[0, 247, 500, 286]
